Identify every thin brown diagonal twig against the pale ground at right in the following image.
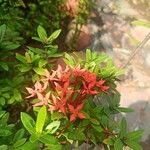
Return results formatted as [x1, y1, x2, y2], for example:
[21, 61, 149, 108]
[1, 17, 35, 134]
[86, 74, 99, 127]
[120, 33, 150, 69]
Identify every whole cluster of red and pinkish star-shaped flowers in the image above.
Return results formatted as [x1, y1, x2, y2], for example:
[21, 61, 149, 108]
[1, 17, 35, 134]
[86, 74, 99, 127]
[26, 65, 109, 122]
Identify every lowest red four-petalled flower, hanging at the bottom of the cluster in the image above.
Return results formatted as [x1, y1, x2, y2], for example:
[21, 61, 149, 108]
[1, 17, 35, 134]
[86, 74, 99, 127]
[68, 103, 85, 122]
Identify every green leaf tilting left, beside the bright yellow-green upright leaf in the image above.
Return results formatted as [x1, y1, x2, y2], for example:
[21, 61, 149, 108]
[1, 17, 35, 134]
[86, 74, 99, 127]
[21, 112, 35, 134]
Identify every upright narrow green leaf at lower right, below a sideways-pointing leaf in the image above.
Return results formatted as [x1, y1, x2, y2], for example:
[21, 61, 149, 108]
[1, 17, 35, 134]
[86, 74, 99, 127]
[119, 118, 127, 138]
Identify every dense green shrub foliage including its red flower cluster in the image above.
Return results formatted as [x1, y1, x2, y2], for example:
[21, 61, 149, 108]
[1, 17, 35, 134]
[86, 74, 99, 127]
[0, 0, 143, 150]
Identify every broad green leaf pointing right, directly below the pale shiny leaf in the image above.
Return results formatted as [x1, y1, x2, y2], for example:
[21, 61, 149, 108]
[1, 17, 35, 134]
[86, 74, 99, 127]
[39, 134, 58, 144]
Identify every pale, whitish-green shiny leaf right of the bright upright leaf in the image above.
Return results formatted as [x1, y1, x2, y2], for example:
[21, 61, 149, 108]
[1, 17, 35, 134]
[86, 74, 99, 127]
[46, 121, 60, 134]
